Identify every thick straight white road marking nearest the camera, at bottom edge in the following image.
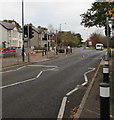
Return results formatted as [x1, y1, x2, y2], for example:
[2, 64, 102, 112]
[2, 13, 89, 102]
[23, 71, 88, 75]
[57, 97, 67, 120]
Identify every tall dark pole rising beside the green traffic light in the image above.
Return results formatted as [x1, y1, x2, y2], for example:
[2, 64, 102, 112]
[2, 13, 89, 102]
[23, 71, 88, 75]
[22, 0, 25, 62]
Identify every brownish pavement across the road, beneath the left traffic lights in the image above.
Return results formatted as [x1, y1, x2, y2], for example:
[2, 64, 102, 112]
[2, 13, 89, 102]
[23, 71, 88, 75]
[0, 51, 66, 71]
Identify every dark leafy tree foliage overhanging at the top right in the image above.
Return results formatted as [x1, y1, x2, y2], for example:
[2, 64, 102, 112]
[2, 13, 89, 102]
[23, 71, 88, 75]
[80, 2, 114, 27]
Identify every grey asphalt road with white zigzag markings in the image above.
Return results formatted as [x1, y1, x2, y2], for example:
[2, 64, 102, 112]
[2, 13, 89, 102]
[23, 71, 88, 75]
[0, 49, 105, 118]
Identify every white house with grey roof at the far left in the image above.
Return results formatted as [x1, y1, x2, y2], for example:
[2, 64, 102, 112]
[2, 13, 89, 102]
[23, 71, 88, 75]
[0, 21, 23, 47]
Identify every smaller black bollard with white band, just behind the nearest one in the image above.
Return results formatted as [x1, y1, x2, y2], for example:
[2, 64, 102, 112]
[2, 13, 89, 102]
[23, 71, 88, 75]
[103, 65, 109, 83]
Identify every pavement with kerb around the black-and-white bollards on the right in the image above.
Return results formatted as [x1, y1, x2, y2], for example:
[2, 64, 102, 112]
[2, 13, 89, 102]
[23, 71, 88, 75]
[74, 50, 114, 120]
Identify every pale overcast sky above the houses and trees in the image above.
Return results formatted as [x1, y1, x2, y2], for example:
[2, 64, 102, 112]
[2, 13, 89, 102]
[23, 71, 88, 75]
[0, 0, 103, 41]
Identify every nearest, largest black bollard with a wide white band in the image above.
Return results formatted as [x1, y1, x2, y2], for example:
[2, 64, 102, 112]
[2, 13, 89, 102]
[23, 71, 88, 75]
[100, 82, 110, 120]
